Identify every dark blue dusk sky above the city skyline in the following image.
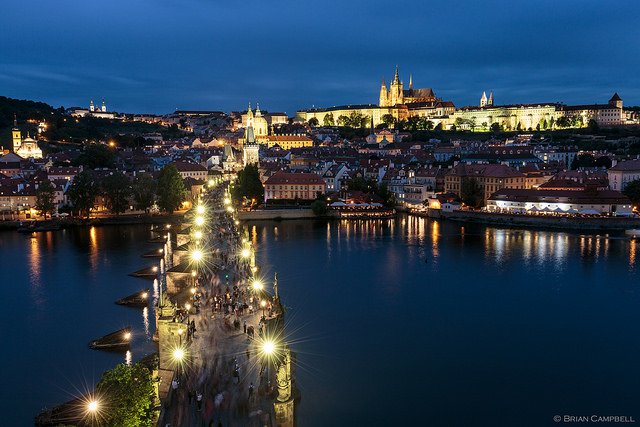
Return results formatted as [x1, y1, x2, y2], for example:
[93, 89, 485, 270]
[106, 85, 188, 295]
[0, 0, 640, 115]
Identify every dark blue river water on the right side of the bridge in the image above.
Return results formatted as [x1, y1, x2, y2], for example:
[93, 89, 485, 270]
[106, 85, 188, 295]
[249, 216, 640, 426]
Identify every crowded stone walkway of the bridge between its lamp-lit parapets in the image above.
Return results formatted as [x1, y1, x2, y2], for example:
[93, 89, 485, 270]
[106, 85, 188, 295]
[161, 182, 288, 427]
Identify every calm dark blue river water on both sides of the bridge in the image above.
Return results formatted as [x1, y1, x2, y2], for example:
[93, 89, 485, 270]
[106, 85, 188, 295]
[0, 217, 640, 426]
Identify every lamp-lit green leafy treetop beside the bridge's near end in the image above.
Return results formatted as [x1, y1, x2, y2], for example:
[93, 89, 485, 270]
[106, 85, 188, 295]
[96, 363, 154, 427]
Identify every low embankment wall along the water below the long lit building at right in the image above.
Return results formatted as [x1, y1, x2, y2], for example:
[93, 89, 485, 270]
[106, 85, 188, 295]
[438, 211, 640, 230]
